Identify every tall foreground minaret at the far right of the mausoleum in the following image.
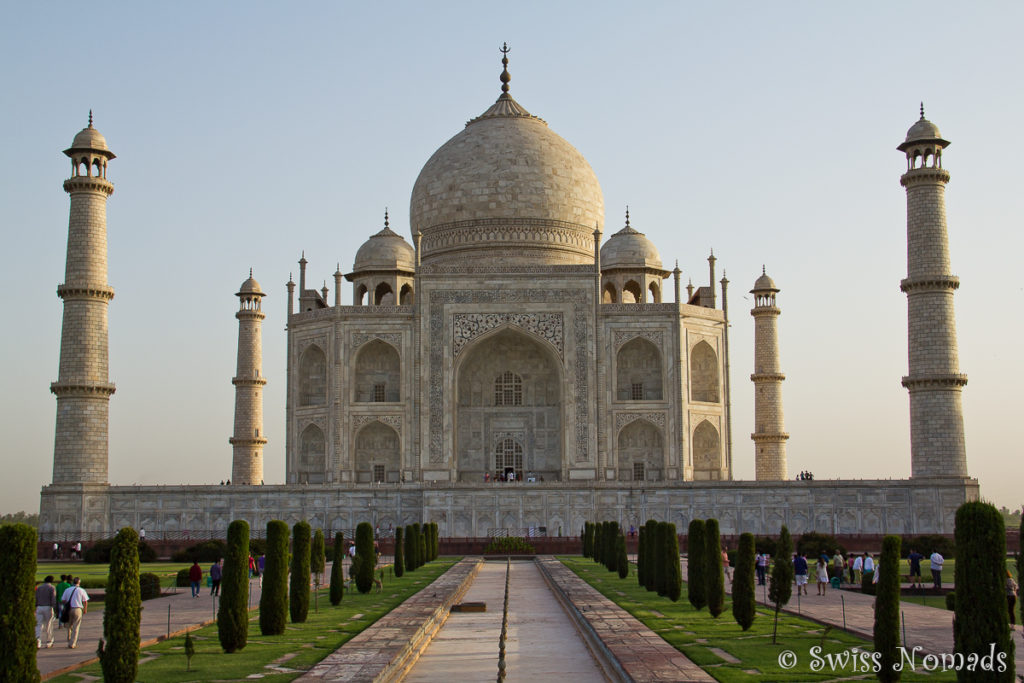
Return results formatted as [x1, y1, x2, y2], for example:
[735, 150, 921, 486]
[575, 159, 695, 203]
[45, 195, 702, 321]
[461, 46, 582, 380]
[897, 104, 968, 477]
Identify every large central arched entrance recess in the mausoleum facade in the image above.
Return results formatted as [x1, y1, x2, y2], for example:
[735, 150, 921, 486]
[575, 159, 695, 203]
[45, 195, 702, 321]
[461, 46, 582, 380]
[454, 328, 564, 481]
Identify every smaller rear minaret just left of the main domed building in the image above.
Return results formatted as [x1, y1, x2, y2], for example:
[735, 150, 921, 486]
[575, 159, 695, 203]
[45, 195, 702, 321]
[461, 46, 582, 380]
[227, 269, 266, 485]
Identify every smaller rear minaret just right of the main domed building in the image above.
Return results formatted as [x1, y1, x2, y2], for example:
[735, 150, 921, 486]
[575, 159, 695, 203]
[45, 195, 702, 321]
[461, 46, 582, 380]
[751, 267, 790, 481]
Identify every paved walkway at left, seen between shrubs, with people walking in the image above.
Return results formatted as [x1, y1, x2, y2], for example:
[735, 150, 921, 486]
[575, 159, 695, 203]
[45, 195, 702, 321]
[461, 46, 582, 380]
[36, 580, 260, 680]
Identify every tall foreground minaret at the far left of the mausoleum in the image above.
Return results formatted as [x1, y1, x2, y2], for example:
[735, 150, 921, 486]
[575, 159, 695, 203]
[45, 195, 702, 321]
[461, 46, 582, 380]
[50, 112, 115, 484]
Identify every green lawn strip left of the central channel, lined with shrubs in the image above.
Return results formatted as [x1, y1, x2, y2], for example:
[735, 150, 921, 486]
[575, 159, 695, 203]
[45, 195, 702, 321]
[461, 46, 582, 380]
[51, 557, 459, 683]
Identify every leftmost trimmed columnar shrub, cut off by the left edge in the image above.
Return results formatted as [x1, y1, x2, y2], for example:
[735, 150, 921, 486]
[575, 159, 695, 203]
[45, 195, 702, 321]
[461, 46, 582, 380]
[0, 523, 38, 682]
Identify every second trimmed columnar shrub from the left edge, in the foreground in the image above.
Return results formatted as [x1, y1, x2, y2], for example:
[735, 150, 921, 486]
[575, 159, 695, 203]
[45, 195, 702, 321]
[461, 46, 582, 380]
[99, 526, 142, 683]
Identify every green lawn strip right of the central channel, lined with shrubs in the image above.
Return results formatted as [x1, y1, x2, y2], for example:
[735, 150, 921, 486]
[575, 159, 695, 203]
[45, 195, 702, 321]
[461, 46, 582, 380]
[558, 556, 956, 683]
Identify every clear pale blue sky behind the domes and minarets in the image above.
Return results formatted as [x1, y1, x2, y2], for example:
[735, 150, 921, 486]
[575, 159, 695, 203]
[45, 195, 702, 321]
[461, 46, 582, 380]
[0, 2, 1024, 512]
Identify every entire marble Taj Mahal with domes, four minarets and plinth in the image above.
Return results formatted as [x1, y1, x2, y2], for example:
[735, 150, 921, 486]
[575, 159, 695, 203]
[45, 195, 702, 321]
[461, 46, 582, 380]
[40, 50, 979, 538]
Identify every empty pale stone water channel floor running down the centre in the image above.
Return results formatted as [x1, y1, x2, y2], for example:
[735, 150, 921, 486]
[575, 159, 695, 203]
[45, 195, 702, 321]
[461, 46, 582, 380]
[403, 561, 605, 683]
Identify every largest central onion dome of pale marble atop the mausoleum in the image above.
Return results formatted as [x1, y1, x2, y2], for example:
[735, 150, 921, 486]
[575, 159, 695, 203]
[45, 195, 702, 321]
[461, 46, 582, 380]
[410, 66, 604, 265]
